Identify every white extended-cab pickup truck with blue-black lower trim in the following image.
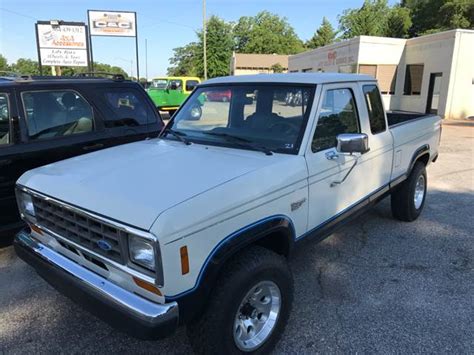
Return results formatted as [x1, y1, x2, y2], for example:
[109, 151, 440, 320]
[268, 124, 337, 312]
[15, 74, 441, 354]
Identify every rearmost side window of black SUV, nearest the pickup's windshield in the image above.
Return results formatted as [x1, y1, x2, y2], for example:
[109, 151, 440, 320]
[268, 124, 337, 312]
[103, 88, 156, 128]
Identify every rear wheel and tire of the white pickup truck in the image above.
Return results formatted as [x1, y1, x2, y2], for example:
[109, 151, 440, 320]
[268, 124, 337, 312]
[391, 162, 428, 222]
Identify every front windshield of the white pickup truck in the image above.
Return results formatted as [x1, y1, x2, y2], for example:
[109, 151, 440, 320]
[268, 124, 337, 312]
[168, 84, 315, 154]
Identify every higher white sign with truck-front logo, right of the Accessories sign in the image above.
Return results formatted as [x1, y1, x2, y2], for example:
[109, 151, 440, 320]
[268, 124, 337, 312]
[87, 10, 137, 37]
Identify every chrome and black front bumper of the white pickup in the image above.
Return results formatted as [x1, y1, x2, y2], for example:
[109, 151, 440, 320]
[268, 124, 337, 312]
[14, 231, 179, 339]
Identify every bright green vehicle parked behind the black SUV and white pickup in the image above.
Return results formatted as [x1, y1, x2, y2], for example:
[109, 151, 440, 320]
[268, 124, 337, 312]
[148, 76, 201, 116]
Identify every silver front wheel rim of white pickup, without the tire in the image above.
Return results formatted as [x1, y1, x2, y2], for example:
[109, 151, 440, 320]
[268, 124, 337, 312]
[233, 281, 281, 352]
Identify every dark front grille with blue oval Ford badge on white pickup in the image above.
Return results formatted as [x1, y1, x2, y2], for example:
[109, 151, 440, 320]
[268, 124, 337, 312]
[33, 196, 127, 264]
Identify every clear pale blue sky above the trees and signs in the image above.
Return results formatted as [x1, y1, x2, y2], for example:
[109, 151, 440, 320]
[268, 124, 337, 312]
[0, 0, 394, 78]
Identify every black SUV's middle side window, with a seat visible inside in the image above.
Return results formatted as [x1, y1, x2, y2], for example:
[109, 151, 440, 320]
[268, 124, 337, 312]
[21, 90, 94, 140]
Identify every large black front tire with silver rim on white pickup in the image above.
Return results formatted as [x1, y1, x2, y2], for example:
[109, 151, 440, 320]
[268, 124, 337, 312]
[187, 246, 293, 354]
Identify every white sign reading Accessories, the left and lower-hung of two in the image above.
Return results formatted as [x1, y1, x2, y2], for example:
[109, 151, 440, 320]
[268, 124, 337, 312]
[36, 21, 89, 67]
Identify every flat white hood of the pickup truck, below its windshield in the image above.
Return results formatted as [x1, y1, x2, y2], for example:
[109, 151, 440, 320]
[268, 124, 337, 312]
[18, 139, 277, 230]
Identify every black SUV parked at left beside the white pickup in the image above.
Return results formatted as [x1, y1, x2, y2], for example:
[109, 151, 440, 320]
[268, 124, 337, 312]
[0, 76, 163, 242]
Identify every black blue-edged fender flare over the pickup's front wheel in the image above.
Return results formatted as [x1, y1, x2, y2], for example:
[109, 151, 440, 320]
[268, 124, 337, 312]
[165, 215, 295, 324]
